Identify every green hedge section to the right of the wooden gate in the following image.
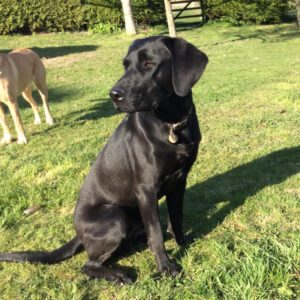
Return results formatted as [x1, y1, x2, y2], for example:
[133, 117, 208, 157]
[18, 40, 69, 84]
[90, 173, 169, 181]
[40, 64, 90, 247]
[206, 0, 288, 25]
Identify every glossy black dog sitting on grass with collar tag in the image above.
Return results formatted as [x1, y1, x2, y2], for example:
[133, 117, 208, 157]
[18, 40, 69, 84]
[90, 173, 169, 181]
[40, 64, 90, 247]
[0, 36, 208, 283]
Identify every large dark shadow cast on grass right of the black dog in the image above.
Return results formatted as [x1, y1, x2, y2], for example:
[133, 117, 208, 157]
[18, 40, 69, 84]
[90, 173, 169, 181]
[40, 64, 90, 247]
[180, 146, 300, 248]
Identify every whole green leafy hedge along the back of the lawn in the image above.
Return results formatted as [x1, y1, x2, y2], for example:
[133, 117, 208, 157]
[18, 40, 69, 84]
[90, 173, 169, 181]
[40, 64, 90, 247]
[0, 0, 294, 34]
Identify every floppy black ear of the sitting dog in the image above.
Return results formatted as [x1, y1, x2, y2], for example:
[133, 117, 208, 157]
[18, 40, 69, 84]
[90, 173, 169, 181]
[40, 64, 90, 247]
[165, 38, 208, 97]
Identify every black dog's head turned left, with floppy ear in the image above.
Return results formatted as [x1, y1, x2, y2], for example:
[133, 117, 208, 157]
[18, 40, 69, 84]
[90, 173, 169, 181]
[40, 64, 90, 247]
[110, 36, 208, 112]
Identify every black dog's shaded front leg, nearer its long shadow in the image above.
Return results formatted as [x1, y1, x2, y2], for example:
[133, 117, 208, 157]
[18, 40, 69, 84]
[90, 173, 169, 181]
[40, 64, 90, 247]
[166, 177, 186, 245]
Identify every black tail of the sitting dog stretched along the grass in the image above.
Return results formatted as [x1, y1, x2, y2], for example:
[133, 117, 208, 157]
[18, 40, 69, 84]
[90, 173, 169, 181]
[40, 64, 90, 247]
[0, 236, 83, 264]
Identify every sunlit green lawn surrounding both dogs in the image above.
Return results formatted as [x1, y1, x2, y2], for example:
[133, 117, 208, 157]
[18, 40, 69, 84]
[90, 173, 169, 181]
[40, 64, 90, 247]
[0, 24, 300, 300]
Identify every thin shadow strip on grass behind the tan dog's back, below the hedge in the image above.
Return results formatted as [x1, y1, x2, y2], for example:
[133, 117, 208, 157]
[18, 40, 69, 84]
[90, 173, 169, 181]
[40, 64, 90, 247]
[1, 45, 99, 58]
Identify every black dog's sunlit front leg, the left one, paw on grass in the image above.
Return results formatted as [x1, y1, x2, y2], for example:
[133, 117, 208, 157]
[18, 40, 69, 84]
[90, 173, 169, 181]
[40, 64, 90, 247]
[138, 193, 178, 276]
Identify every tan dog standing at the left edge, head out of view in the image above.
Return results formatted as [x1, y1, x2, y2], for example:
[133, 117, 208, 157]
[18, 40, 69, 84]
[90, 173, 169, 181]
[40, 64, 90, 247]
[0, 49, 53, 145]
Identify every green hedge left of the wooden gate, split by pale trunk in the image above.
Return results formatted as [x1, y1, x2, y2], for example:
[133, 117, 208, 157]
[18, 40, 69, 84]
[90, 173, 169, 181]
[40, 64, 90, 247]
[0, 0, 164, 34]
